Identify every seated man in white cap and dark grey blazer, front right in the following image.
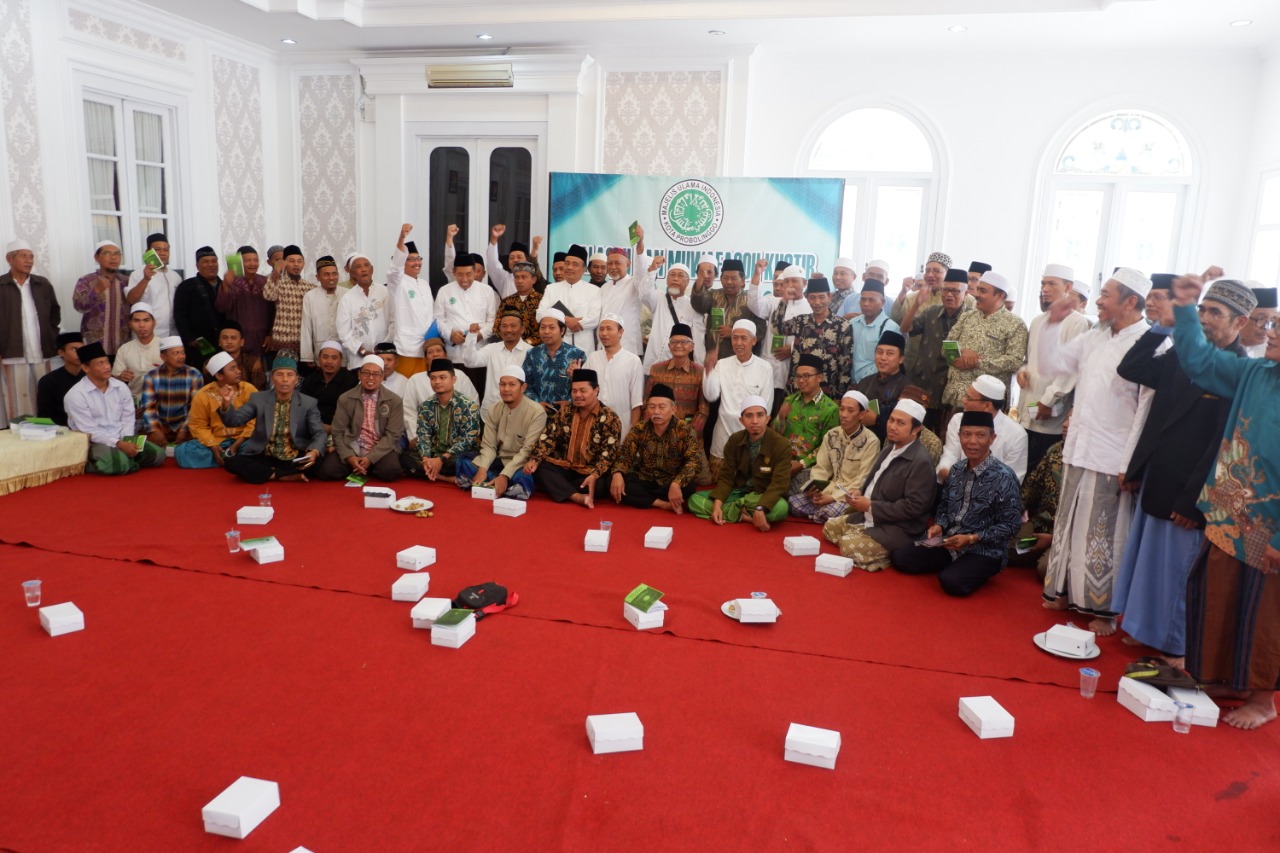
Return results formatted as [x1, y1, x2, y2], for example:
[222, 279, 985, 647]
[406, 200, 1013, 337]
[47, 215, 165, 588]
[822, 400, 938, 571]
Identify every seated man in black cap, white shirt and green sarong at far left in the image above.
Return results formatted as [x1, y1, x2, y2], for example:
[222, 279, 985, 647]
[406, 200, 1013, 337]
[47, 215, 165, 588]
[64, 341, 164, 475]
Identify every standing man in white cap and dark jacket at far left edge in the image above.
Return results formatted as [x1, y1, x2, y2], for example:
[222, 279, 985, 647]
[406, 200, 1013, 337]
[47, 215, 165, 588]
[0, 240, 63, 427]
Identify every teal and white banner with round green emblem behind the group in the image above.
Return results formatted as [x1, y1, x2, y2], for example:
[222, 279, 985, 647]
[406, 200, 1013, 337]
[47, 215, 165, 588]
[545, 172, 845, 280]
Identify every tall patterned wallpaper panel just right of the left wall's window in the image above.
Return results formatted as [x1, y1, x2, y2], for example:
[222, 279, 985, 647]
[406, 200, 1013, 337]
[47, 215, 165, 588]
[212, 54, 266, 251]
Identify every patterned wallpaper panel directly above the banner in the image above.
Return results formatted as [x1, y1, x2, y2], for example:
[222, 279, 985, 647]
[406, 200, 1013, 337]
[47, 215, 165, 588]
[604, 70, 723, 174]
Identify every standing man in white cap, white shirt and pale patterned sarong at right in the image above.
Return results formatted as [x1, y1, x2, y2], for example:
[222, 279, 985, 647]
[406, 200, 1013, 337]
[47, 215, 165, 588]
[1038, 266, 1151, 635]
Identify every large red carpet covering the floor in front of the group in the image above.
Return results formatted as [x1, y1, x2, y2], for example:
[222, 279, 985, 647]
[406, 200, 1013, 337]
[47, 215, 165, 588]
[0, 469, 1280, 853]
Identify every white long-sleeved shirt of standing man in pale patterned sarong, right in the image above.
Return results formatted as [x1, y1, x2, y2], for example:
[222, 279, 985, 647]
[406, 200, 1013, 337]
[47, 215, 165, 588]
[1039, 320, 1147, 476]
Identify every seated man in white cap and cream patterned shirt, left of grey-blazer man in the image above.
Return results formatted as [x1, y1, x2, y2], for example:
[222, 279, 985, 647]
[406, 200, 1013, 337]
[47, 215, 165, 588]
[787, 391, 879, 524]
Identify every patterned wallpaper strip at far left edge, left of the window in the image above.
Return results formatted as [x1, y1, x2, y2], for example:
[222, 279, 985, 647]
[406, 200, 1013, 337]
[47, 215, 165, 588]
[0, 0, 49, 258]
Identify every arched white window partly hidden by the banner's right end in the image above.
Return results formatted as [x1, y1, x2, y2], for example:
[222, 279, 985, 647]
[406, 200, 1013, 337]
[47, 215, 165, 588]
[808, 106, 936, 277]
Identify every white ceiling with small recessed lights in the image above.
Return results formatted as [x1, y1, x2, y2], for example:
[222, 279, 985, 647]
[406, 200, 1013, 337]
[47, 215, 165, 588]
[142, 0, 1280, 60]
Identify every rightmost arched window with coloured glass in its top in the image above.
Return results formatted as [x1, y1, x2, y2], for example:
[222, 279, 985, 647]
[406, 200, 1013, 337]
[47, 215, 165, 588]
[1033, 110, 1194, 287]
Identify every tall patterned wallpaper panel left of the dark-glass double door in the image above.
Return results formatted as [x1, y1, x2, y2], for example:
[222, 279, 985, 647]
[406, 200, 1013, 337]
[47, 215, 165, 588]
[298, 74, 357, 261]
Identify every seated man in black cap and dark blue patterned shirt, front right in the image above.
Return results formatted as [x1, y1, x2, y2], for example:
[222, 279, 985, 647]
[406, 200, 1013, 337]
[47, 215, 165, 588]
[891, 411, 1023, 597]
